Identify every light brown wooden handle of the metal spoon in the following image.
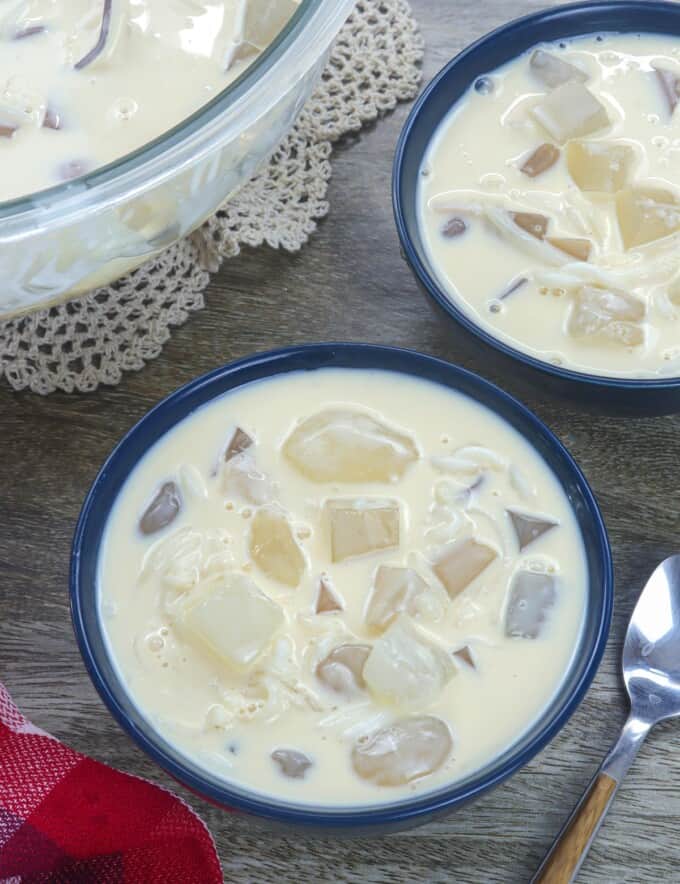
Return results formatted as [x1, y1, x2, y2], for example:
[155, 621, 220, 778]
[532, 772, 618, 884]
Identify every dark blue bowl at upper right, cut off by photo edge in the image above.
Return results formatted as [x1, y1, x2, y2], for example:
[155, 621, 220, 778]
[392, 0, 680, 415]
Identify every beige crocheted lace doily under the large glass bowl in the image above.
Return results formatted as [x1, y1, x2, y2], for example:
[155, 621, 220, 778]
[0, 0, 423, 394]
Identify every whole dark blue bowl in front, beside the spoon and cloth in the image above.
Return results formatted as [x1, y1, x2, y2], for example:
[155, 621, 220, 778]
[70, 344, 613, 833]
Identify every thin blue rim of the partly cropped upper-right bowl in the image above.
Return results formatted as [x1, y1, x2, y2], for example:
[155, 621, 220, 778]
[392, 0, 680, 392]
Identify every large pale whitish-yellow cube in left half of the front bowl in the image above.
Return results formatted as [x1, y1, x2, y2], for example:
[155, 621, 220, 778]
[180, 574, 284, 667]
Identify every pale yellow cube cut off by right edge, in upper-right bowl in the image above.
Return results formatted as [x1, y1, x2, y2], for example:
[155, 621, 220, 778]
[616, 188, 680, 249]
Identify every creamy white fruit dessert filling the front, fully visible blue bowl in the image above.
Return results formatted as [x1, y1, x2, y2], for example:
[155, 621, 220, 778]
[98, 369, 588, 806]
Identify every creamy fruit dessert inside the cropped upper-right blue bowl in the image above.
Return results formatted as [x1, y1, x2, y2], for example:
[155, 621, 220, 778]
[419, 34, 680, 378]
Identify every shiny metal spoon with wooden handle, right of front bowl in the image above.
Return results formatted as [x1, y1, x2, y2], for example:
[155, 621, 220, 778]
[531, 555, 680, 884]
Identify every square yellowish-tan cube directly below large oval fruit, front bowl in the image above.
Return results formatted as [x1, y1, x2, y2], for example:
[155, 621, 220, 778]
[326, 498, 399, 562]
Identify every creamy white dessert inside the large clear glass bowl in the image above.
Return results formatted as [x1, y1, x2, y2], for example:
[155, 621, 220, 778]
[0, 0, 297, 200]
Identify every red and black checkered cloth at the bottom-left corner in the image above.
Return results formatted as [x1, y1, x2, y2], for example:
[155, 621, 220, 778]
[0, 684, 222, 884]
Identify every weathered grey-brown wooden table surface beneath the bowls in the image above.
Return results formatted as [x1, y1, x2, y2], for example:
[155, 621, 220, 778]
[0, 0, 680, 884]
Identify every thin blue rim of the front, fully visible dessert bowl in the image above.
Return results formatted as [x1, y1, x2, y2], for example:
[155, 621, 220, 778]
[69, 343, 613, 829]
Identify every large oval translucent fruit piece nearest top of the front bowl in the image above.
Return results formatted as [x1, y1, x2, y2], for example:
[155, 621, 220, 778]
[283, 409, 418, 482]
